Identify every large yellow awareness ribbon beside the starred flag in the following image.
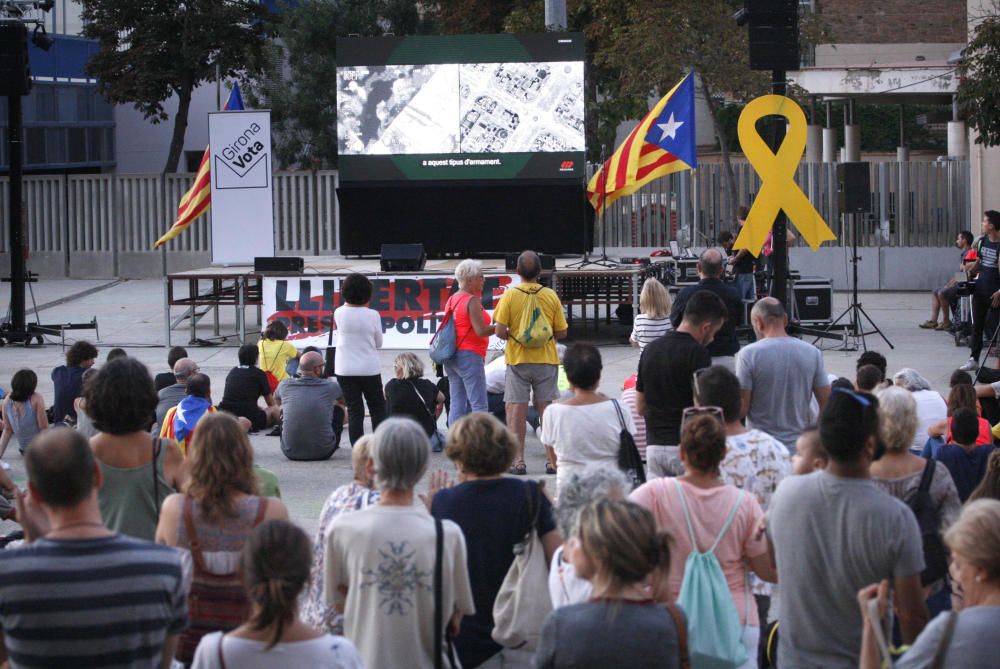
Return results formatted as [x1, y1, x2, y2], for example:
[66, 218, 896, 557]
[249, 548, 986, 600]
[733, 95, 837, 254]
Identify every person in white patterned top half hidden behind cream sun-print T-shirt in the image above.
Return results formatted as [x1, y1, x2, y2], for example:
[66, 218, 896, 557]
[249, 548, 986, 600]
[302, 435, 379, 634]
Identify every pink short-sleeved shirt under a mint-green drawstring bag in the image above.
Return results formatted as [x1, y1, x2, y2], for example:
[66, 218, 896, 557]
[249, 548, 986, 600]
[630, 478, 767, 626]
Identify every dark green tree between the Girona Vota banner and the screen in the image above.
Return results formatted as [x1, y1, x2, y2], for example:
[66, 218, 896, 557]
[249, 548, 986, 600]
[247, 0, 427, 168]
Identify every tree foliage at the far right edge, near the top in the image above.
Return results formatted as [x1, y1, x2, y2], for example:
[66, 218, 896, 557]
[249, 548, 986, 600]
[958, 14, 1000, 146]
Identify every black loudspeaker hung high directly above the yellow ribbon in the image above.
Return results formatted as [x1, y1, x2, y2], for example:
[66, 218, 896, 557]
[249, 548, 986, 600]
[746, 0, 801, 71]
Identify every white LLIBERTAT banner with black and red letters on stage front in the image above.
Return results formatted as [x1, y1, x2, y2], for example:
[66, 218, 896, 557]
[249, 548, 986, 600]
[261, 273, 521, 350]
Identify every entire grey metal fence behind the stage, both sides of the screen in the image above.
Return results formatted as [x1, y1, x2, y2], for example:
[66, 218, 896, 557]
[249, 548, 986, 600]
[0, 162, 971, 277]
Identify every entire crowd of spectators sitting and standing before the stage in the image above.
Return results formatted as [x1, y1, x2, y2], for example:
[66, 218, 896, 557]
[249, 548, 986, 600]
[0, 252, 1000, 669]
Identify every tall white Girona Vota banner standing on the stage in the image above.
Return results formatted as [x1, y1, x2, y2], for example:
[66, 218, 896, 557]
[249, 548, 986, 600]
[208, 111, 274, 265]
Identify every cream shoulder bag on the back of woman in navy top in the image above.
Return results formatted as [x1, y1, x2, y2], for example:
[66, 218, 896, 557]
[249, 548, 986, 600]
[491, 483, 552, 651]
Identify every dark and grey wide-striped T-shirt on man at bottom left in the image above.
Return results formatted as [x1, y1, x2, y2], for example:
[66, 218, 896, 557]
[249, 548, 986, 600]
[0, 534, 187, 669]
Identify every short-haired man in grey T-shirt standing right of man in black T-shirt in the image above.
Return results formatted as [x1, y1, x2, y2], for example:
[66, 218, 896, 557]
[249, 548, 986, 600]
[736, 297, 830, 451]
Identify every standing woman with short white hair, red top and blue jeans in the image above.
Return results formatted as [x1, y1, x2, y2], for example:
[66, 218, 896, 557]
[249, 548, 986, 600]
[444, 259, 495, 425]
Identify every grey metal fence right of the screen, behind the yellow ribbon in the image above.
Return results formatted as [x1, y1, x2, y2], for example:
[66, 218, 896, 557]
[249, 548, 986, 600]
[597, 161, 971, 247]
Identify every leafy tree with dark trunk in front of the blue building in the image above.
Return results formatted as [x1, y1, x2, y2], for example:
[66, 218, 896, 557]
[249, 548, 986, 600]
[82, 0, 267, 172]
